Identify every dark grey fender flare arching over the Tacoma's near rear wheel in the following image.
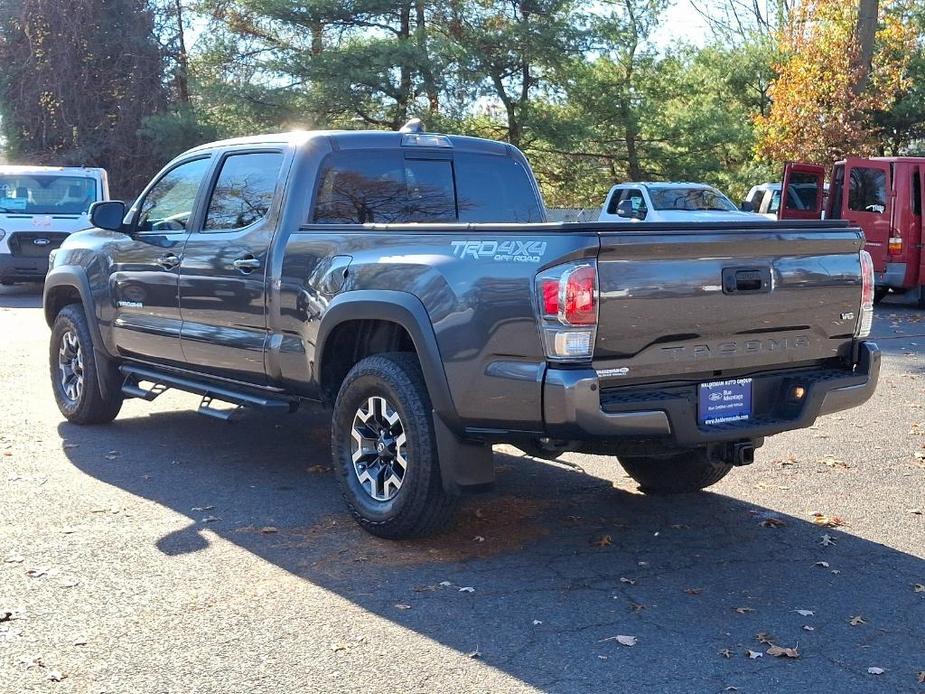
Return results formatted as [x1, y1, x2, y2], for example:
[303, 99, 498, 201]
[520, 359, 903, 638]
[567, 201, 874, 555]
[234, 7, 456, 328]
[315, 289, 458, 428]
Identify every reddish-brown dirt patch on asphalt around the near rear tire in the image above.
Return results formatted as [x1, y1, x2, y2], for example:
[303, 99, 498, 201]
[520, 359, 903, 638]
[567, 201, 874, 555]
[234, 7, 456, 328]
[278, 496, 549, 572]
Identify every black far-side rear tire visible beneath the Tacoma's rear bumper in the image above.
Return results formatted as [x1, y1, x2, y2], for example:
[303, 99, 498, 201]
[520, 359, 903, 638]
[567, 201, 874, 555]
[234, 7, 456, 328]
[620, 450, 732, 494]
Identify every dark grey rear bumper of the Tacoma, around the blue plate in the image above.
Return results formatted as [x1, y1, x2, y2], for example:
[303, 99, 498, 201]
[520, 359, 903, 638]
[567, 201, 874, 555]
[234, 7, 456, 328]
[543, 342, 880, 446]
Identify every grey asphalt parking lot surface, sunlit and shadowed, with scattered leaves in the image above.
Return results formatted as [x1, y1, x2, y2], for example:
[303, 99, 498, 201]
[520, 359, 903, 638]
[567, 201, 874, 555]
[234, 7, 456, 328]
[0, 287, 925, 693]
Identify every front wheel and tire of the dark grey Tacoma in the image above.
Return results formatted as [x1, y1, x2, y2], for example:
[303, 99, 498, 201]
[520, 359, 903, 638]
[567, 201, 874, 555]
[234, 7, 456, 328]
[48, 304, 123, 424]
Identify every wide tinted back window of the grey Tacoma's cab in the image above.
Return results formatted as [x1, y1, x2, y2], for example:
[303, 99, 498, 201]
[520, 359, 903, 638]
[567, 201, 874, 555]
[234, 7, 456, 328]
[311, 150, 543, 224]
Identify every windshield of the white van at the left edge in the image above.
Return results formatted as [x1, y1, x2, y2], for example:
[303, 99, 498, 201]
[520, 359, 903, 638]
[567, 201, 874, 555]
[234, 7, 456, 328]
[0, 174, 97, 214]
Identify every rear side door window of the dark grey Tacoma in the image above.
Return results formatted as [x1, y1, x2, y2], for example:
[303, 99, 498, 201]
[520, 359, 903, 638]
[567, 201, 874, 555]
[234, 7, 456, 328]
[203, 152, 283, 231]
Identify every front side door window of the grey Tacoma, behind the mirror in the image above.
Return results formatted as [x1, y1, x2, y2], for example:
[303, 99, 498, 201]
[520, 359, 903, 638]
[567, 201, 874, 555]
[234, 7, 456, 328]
[136, 157, 209, 231]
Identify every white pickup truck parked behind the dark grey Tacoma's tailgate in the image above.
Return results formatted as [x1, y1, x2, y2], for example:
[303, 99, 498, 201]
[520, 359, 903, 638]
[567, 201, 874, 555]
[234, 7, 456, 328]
[598, 182, 762, 222]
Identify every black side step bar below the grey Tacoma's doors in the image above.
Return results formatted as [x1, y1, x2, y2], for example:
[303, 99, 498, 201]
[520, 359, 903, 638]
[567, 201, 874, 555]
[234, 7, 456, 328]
[119, 365, 299, 420]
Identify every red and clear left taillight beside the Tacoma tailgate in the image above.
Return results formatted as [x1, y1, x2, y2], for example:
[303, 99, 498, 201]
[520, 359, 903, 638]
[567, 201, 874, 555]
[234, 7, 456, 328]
[536, 260, 598, 361]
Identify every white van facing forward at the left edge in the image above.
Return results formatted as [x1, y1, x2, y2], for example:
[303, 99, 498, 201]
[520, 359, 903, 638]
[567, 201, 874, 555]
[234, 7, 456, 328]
[0, 166, 109, 285]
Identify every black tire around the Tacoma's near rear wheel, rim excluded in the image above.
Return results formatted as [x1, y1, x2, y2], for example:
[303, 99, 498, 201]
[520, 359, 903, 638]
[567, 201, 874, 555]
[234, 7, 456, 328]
[331, 352, 456, 540]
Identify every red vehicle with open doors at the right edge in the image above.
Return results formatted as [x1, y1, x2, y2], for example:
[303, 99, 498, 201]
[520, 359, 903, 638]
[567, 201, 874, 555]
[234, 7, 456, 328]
[777, 162, 925, 307]
